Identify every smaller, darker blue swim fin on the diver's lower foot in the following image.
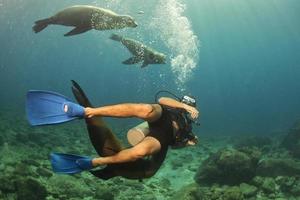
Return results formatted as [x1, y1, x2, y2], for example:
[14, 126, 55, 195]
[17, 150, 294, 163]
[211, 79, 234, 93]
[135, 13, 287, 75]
[50, 153, 93, 174]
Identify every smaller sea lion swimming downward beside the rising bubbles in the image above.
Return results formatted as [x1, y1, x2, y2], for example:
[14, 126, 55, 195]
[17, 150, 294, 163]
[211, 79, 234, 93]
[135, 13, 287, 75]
[110, 34, 166, 68]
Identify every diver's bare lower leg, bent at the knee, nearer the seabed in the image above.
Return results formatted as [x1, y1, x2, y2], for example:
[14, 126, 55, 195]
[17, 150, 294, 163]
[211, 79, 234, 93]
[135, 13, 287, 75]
[92, 137, 161, 167]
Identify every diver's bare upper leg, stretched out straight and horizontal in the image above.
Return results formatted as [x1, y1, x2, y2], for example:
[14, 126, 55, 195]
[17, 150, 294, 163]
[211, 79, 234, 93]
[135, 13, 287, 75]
[85, 103, 162, 121]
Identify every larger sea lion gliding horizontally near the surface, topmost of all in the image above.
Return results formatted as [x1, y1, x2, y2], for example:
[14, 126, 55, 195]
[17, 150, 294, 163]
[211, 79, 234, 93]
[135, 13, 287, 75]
[33, 5, 137, 36]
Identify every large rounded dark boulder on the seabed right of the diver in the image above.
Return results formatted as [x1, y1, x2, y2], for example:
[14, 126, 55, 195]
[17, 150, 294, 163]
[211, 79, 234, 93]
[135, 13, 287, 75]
[195, 149, 258, 185]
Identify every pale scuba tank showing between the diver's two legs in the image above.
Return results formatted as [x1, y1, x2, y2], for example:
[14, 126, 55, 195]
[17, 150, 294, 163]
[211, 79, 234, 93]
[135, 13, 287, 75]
[127, 122, 150, 146]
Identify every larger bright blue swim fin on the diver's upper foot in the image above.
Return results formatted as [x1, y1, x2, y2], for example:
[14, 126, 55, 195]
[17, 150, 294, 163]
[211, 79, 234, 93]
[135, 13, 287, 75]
[26, 90, 84, 126]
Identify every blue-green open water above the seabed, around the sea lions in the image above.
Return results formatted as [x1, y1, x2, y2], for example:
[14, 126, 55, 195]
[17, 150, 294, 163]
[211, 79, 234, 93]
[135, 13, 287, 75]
[0, 0, 300, 135]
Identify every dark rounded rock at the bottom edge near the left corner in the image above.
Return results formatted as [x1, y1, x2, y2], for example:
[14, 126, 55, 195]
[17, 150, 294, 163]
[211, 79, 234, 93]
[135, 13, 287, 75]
[16, 178, 47, 200]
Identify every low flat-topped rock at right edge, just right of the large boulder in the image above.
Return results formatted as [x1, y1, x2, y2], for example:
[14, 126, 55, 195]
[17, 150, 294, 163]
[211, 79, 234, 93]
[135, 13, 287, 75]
[256, 158, 300, 177]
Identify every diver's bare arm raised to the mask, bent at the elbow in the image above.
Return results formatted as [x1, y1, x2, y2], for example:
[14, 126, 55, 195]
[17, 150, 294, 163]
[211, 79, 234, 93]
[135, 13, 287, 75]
[158, 97, 199, 119]
